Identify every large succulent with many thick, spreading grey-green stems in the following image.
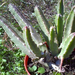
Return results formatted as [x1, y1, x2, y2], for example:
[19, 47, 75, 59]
[0, 0, 75, 72]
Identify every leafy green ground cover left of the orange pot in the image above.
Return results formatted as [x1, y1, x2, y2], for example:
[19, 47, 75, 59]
[0, 39, 27, 75]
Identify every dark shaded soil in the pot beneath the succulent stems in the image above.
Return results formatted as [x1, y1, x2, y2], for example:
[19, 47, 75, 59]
[28, 51, 75, 75]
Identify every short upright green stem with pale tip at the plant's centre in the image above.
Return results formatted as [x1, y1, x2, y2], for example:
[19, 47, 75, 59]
[50, 26, 58, 56]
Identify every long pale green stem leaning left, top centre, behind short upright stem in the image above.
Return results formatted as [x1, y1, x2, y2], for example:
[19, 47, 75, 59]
[34, 6, 50, 44]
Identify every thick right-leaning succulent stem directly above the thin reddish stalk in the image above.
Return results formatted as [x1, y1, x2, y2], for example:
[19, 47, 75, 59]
[58, 32, 75, 58]
